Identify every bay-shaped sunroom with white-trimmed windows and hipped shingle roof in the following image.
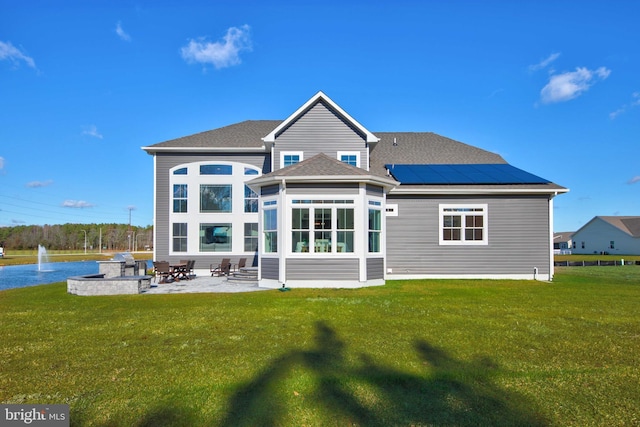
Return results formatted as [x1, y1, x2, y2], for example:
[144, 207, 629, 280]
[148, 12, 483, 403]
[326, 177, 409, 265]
[247, 154, 397, 288]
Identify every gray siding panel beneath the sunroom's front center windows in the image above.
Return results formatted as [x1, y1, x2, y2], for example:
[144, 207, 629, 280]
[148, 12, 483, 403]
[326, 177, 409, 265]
[284, 258, 359, 280]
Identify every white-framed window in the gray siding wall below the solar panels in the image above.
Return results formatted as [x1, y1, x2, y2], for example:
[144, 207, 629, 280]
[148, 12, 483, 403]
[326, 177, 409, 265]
[440, 205, 487, 245]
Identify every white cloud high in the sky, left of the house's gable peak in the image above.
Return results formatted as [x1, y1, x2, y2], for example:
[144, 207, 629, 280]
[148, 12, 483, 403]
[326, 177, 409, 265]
[181, 25, 251, 69]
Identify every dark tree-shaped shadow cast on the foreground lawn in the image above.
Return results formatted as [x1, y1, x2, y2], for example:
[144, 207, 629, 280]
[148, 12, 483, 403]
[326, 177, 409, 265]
[220, 322, 548, 427]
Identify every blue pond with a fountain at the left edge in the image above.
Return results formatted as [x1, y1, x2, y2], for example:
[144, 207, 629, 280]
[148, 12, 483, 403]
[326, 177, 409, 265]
[0, 261, 98, 291]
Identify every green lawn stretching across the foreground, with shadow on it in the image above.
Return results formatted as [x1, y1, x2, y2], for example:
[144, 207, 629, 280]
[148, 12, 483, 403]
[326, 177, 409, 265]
[0, 266, 640, 426]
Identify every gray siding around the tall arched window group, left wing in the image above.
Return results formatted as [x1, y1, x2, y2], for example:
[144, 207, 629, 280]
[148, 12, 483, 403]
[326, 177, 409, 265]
[154, 153, 271, 269]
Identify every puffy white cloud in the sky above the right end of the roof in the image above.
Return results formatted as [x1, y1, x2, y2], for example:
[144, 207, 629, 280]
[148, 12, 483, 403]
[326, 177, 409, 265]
[540, 67, 611, 104]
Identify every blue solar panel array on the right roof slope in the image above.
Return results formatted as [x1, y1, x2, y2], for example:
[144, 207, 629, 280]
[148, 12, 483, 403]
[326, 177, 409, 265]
[385, 163, 551, 184]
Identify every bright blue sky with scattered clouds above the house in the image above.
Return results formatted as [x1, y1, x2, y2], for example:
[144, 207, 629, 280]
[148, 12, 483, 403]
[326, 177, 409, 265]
[0, 0, 640, 231]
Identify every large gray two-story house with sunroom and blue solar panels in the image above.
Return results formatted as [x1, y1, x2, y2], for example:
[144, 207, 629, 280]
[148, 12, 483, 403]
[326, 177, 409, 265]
[143, 92, 568, 287]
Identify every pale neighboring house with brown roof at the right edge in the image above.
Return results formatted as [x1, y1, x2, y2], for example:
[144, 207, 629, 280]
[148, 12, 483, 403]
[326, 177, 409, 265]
[572, 216, 640, 255]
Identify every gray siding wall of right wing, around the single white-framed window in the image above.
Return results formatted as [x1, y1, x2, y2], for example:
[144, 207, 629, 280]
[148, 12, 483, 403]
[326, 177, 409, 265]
[386, 195, 551, 275]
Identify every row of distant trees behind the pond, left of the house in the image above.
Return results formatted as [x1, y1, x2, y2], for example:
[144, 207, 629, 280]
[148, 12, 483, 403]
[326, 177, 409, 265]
[0, 224, 153, 251]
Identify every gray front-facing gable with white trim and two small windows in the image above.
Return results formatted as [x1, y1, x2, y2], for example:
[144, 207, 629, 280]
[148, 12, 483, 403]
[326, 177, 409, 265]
[262, 92, 379, 171]
